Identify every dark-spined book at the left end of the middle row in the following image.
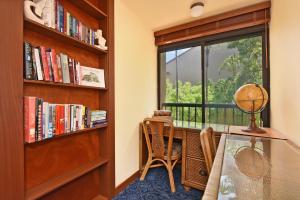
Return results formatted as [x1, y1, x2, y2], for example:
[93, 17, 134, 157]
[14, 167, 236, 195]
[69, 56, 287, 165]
[24, 42, 35, 80]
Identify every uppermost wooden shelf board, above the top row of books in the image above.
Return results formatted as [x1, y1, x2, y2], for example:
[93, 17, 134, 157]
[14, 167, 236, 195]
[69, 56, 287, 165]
[70, 0, 107, 19]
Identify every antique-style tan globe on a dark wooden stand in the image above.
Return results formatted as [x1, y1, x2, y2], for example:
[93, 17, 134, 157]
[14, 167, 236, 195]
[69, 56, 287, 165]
[234, 83, 269, 133]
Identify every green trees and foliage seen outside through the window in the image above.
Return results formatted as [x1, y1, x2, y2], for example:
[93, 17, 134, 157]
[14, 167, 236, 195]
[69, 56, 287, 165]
[165, 37, 262, 125]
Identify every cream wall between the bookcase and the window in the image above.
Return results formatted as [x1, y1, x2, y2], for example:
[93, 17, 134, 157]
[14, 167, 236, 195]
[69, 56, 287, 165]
[115, 0, 157, 186]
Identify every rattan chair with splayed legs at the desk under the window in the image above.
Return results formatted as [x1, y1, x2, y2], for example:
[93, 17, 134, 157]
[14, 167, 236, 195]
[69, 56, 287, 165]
[140, 117, 181, 192]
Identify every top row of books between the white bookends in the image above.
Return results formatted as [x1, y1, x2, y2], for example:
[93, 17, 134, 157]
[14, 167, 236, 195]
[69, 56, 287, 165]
[42, 0, 95, 45]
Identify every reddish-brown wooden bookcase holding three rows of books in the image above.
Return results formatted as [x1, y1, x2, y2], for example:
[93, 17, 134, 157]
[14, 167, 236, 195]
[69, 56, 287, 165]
[21, 0, 115, 200]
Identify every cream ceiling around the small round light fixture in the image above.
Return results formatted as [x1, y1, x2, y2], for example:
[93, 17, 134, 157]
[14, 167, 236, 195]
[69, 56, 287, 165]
[122, 0, 268, 31]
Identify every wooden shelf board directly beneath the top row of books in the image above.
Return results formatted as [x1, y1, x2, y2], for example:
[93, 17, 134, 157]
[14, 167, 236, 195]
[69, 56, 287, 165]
[24, 18, 107, 54]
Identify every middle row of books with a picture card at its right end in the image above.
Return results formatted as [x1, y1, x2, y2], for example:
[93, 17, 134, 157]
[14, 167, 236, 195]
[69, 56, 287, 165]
[24, 42, 105, 87]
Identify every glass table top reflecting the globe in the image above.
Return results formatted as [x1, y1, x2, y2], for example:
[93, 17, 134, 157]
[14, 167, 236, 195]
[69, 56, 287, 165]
[218, 135, 300, 200]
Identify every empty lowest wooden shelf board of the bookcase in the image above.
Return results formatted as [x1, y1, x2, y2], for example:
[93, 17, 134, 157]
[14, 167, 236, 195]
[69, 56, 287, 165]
[25, 158, 108, 200]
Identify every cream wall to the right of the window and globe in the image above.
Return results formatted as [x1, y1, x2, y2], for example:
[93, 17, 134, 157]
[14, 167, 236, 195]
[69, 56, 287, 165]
[270, 0, 300, 145]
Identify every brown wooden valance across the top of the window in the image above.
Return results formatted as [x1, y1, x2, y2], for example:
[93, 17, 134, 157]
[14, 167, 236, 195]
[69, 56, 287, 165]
[154, 1, 271, 46]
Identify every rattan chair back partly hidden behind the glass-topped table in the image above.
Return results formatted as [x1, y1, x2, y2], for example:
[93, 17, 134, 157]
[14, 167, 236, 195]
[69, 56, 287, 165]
[200, 127, 217, 174]
